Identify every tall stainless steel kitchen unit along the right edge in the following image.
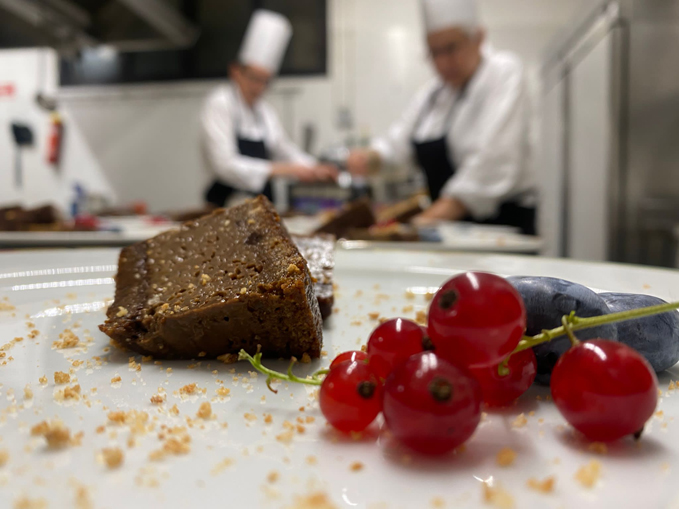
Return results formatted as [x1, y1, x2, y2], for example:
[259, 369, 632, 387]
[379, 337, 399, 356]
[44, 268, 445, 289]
[540, 0, 679, 265]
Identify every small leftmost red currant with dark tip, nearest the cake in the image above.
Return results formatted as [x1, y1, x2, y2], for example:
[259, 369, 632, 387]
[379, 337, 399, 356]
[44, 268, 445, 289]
[319, 361, 382, 433]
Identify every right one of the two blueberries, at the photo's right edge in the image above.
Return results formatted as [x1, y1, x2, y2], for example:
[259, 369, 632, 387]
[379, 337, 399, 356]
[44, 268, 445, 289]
[599, 293, 679, 373]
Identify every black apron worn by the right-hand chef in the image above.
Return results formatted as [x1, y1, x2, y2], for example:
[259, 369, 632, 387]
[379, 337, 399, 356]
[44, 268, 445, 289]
[412, 87, 535, 235]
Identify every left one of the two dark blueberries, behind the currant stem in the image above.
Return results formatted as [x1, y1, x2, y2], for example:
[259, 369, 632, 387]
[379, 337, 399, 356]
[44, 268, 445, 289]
[507, 277, 618, 385]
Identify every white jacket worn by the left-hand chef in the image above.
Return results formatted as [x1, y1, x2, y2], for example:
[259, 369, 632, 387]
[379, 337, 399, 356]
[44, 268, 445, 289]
[201, 85, 316, 193]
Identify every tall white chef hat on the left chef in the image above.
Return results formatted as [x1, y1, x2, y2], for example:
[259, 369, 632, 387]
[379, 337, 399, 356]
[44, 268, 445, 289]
[238, 9, 292, 74]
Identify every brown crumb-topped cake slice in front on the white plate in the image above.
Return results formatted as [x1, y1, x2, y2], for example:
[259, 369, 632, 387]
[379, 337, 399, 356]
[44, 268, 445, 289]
[100, 196, 322, 359]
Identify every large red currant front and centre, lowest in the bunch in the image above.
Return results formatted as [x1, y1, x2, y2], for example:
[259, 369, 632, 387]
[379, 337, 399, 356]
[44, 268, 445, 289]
[382, 352, 481, 455]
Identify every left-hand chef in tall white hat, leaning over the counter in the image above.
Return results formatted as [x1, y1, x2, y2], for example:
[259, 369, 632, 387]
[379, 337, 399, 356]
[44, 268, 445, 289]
[201, 10, 337, 207]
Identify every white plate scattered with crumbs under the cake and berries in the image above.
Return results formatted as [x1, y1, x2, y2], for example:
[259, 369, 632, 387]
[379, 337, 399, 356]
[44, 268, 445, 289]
[0, 250, 679, 509]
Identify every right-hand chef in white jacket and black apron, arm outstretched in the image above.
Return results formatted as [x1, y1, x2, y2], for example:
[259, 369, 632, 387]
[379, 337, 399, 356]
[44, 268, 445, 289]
[348, 0, 536, 234]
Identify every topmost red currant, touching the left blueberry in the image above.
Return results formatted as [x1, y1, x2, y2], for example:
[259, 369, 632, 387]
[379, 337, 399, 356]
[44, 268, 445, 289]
[428, 272, 526, 367]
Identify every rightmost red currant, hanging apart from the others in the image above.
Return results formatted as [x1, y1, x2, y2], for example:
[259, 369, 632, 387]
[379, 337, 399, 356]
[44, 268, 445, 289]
[550, 339, 658, 442]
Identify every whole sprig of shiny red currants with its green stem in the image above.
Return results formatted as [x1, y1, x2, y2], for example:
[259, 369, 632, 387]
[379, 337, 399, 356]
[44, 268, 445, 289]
[242, 272, 658, 454]
